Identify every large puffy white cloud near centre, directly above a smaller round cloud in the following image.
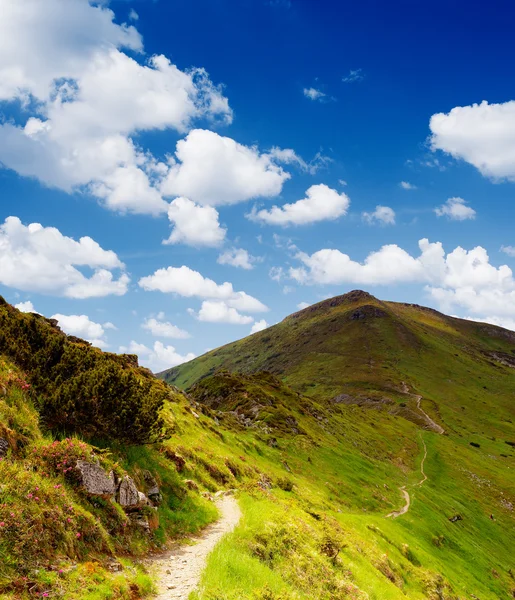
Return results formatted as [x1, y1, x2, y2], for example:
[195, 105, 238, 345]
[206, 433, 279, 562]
[162, 129, 290, 206]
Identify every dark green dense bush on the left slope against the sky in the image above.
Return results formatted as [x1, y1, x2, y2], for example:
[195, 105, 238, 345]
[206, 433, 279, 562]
[0, 297, 171, 443]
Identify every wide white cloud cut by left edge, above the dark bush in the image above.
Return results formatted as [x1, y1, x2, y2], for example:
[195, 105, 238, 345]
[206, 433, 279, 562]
[0, 217, 129, 298]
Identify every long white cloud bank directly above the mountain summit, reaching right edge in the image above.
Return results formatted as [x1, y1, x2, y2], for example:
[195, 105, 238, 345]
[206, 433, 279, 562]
[289, 239, 515, 318]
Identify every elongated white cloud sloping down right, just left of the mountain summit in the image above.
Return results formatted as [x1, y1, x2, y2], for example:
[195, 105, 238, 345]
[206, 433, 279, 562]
[139, 266, 268, 313]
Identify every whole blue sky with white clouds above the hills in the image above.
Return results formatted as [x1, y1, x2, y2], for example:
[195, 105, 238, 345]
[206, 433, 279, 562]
[0, 0, 515, 370]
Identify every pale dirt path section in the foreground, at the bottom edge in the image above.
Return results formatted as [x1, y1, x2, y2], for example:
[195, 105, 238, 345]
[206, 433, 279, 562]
[153, 496, 241, 600]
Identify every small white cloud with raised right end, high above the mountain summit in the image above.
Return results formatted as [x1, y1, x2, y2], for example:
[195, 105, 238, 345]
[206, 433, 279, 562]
[247, 184, 350, 227]
